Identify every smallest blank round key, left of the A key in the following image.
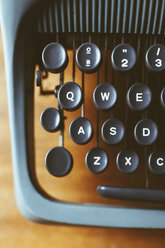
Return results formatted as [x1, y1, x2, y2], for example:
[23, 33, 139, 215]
[40, 108, 61, 132]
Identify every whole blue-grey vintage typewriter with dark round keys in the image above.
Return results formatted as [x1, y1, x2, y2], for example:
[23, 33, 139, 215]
[0, 0, 165, 228]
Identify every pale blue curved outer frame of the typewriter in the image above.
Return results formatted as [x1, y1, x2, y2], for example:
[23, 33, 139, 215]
[0, 0, 165, 228]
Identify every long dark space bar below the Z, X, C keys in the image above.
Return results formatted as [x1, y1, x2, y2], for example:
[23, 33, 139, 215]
[97, 185, 165, 203]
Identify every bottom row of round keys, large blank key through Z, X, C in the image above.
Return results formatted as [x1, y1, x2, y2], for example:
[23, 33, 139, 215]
[45, 147, 165, 177]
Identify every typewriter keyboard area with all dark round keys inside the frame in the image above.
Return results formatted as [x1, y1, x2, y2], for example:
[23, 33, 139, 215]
[35, 34, 165, 203]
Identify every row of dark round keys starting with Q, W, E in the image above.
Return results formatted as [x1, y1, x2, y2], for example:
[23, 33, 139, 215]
[39, 82, 165, 111]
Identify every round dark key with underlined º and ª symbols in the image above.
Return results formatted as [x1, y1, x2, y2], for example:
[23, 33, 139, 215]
[76, 42, 101, 73]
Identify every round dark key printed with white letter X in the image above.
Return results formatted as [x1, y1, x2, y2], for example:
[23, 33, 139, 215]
[116, 149, 139, 174]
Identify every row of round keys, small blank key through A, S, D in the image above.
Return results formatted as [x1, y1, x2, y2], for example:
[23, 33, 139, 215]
[41, 111, 158, 146]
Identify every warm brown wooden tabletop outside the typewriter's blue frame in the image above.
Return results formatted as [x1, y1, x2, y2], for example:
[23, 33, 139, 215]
[0, 29, 165, 248]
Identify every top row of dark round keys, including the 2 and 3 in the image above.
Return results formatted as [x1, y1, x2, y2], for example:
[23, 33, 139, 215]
[42, 42, 165, 73]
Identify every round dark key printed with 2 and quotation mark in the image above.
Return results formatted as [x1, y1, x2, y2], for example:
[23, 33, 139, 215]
[111, 43, 136, 72]
